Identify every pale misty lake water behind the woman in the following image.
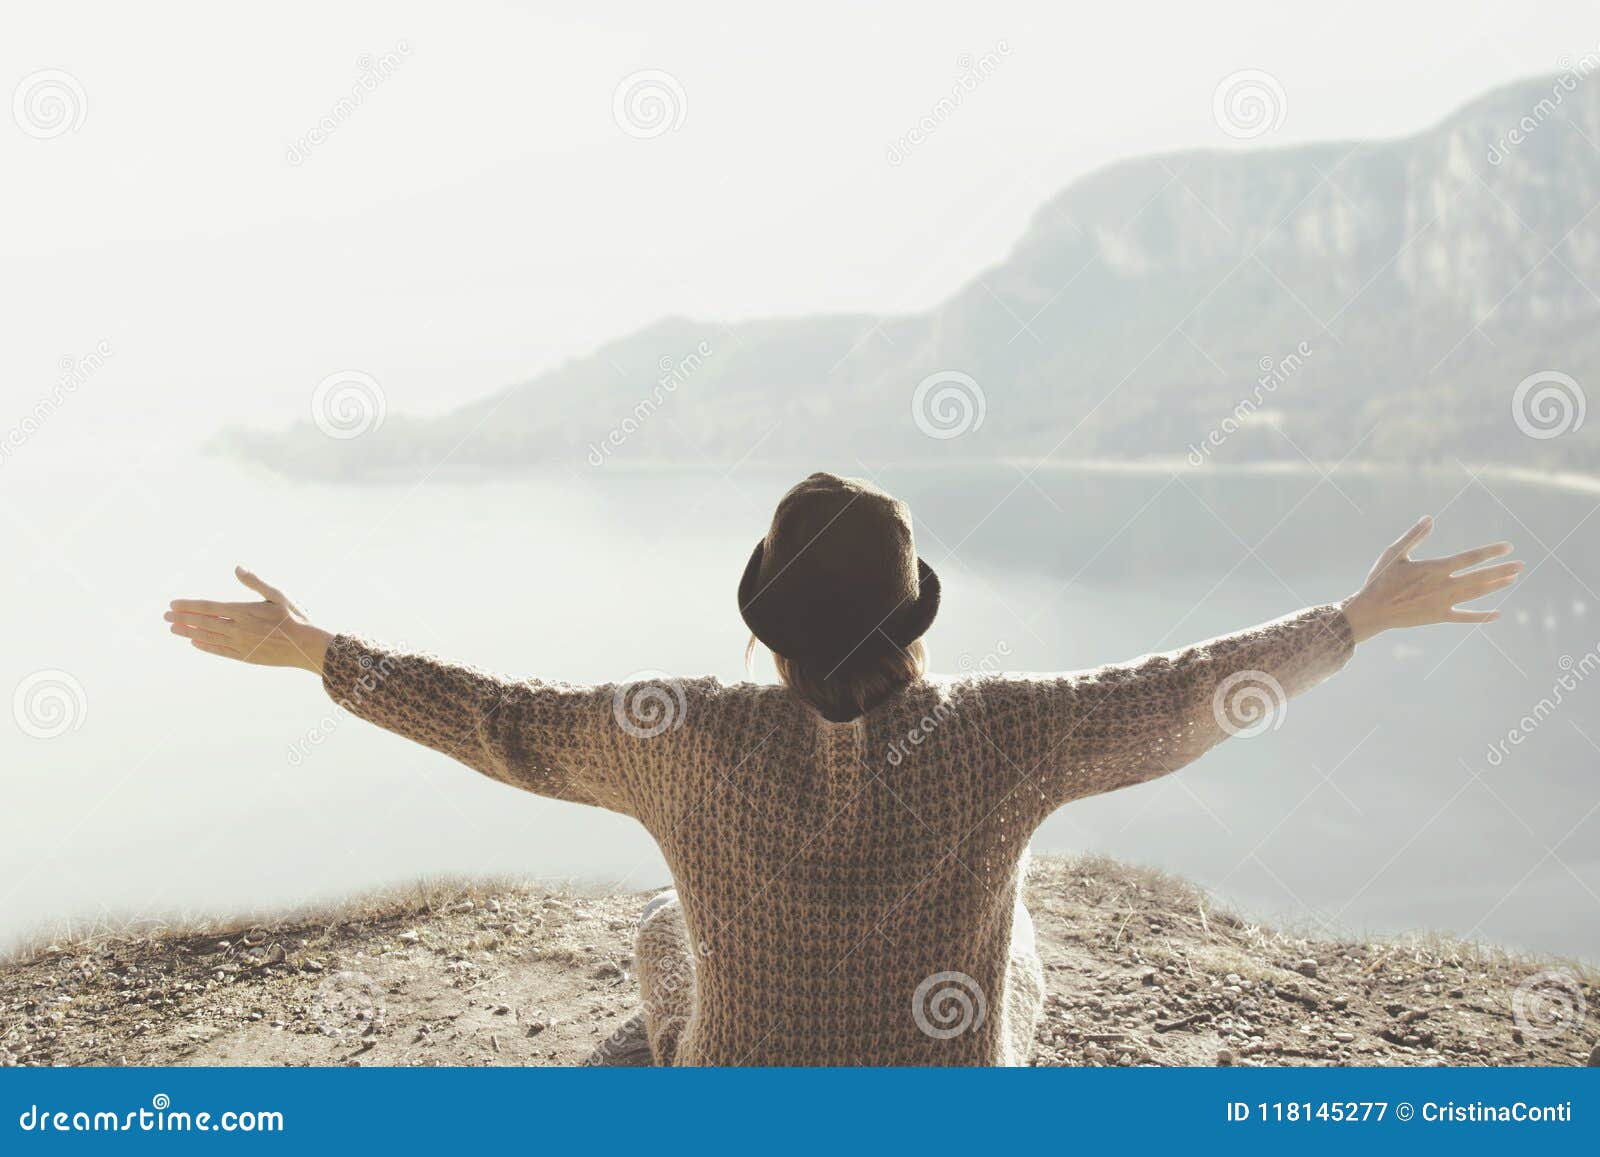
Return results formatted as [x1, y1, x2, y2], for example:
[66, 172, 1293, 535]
[0, 456, 1600, 960]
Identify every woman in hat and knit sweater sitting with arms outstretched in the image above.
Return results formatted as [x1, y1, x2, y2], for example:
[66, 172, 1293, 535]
[166, 474, 1522, 1064]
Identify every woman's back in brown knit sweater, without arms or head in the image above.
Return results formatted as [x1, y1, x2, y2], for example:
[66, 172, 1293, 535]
[640, 682, 1038, 1064]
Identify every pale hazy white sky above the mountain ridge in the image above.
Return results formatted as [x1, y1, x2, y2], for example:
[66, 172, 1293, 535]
[0, 0, 1600, 453]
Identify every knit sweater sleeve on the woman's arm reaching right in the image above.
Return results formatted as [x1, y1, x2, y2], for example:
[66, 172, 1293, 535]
[984, 605, 1355, 818]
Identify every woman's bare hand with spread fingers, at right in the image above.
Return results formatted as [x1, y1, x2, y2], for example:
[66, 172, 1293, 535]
[1344, 517, 1525, 642]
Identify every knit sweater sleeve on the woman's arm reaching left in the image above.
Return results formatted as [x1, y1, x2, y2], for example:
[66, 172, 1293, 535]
[322, 635, 659, 816]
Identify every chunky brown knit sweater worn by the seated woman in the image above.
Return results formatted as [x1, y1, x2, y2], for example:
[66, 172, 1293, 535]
[323, 605, 1354, 1064]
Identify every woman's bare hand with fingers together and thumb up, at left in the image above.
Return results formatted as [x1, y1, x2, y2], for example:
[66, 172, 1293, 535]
[163, 566, 333, 675]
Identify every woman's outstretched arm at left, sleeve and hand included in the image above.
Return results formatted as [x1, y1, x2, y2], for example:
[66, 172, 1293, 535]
[166, 568, 636, 815]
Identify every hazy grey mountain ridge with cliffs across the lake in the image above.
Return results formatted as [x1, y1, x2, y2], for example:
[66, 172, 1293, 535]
[222, 72, 1600, 477]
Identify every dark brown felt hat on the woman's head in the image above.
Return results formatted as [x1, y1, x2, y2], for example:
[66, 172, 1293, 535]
[739, 474, 939, 674]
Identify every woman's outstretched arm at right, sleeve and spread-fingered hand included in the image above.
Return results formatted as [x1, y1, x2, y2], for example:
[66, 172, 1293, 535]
[986, 518, 1523, 815]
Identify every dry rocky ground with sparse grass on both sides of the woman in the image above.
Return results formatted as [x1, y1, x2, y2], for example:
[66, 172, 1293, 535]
[0, 858, 1600, 1066]
